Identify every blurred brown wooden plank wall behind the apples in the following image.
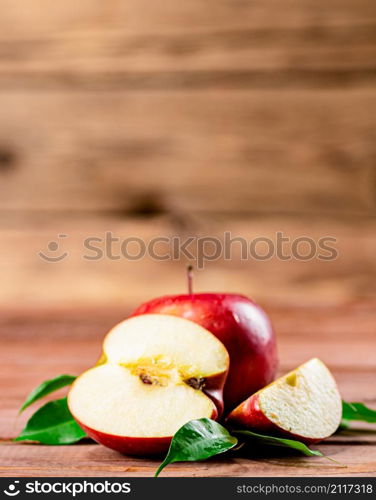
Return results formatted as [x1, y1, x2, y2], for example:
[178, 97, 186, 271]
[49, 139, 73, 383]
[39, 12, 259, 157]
[0, 0, 376, 307]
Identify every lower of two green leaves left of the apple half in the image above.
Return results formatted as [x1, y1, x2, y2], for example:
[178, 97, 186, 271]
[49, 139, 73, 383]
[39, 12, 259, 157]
[14, 398, 86, 444]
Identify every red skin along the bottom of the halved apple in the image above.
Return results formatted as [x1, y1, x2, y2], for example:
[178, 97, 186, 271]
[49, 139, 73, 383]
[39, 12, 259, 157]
[73, 410, 218, 457]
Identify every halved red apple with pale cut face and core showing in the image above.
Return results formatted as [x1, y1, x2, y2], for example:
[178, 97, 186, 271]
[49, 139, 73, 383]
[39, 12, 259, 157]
[68, 314, 229, 455]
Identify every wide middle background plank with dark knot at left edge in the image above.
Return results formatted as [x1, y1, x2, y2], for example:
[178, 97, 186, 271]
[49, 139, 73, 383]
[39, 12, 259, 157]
[0, 89, 376, 216]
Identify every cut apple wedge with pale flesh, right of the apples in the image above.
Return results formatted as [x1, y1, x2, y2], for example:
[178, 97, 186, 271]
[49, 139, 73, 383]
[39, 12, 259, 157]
[228, 358, 342, 443]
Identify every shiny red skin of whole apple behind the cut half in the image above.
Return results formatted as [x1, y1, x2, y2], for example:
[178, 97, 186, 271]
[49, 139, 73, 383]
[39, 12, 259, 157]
[133, 293, 278, 412]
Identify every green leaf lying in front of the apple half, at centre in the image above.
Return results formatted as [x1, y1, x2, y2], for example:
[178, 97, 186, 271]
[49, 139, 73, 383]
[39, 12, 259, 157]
[155, 418, 238, 477]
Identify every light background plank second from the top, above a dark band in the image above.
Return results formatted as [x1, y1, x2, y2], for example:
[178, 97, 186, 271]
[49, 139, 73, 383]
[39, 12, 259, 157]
[0, 24, 375, 72]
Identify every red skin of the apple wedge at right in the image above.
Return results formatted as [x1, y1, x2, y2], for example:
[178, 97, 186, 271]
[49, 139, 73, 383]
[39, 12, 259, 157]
[227, 394, 322, 444]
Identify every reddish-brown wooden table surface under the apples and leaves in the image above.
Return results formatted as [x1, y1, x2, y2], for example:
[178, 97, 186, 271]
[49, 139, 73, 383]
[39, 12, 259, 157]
[0, 301, 376, 477]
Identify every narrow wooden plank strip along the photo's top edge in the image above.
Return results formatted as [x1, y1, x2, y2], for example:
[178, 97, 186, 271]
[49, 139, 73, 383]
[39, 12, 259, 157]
[1, 0, 376, 38]
